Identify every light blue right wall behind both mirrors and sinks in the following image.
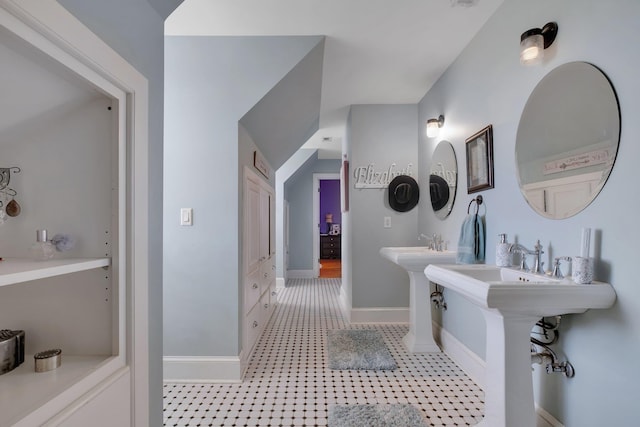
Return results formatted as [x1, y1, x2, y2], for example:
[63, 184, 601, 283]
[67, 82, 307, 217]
[419, 0, 640, 427]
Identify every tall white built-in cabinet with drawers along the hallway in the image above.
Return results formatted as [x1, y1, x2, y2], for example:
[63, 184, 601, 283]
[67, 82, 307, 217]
[242, 168, 277, 370]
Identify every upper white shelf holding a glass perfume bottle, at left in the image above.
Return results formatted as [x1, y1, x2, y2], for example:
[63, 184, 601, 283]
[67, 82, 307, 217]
[0, 258, 111, 286]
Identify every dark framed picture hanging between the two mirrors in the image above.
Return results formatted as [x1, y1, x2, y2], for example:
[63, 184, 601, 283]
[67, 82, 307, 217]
[465, 125, 493, 194]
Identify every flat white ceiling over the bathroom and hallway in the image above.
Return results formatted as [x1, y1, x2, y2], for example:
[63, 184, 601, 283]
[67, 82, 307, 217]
[165, 0, 504, 158]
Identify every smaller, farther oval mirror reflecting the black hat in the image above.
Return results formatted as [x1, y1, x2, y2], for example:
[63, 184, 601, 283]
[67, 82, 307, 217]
[429, 141, 458, 219]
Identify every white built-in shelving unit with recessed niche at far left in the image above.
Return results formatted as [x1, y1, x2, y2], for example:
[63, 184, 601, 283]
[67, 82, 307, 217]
[0, 4, 149, 427]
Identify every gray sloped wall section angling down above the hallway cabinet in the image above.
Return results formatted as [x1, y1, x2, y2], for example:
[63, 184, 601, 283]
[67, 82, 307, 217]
[240, 38, 324, 169]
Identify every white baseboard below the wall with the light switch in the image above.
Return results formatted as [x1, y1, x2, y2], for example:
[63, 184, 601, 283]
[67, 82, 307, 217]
[162, 356, 242, 383]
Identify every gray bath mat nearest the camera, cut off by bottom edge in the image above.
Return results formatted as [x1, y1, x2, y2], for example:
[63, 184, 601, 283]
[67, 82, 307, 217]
[329, 404, 427, 427]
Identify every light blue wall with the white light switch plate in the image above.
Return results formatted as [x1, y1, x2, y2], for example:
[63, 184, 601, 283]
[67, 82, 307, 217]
[164, 36, 319, 356]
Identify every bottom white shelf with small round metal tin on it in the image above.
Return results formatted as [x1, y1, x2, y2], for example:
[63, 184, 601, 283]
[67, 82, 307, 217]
[0, 353, 121, 426]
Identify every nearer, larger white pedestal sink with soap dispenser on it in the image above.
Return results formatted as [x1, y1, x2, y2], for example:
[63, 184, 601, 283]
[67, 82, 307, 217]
[424, 265, 616, 427]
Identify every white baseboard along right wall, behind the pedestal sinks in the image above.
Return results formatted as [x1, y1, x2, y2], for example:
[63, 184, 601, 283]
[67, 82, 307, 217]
[433, 322, 564, 427]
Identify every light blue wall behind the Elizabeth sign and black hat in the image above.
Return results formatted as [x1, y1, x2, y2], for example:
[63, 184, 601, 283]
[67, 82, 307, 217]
[350, 104, 420, 308]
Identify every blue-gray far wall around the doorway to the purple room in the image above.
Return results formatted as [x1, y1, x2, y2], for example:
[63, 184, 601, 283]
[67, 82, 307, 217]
[285, 155, 340, 270]
